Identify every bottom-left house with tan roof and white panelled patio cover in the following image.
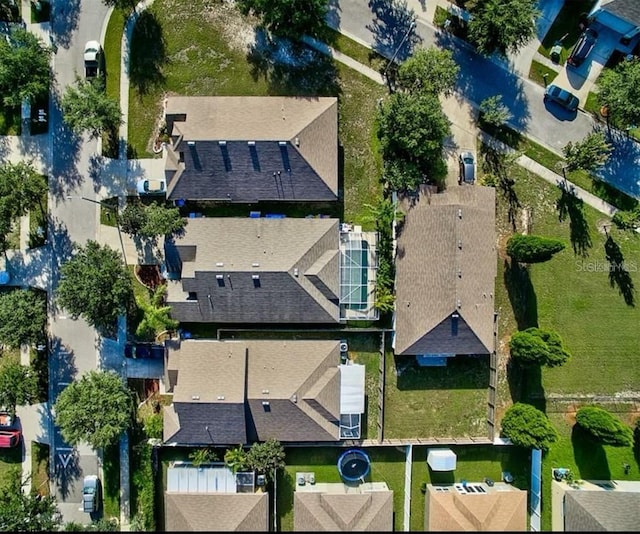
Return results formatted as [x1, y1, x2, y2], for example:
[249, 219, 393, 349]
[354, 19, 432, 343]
[163, 462, 269, 532]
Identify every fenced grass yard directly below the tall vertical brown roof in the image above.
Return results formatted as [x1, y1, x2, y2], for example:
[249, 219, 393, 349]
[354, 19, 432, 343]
[384, 352, 489, 439]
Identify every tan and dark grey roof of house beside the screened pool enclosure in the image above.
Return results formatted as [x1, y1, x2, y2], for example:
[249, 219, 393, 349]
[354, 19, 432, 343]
[165, 217, 340, 323]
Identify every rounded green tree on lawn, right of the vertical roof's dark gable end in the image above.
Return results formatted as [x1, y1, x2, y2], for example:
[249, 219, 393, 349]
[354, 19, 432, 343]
[509, 327, 570, 367]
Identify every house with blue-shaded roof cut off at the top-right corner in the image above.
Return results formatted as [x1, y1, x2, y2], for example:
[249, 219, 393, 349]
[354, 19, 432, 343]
[589, 0, 640, 46]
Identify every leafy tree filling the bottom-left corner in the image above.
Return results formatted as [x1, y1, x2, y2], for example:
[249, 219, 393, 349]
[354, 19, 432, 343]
[0, 467, 62, 532]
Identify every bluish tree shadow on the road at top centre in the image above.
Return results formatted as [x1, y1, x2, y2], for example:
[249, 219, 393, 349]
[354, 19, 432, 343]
[366, 0, 422, 63]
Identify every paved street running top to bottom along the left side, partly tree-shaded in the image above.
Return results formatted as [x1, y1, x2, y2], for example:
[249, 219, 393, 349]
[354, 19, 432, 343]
[49, 0, 108, 523]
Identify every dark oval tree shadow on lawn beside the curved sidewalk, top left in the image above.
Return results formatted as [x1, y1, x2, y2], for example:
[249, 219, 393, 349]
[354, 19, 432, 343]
[128, 11, 169, 95]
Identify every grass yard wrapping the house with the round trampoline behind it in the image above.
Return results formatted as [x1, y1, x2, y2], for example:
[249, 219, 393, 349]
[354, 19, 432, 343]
[276, 447, 405, 532]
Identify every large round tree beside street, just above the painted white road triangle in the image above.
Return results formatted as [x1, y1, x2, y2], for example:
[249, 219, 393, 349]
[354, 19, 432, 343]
[55, 371, 133, 449]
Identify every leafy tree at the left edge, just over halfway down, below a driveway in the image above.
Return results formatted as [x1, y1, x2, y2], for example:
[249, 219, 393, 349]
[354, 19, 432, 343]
[0, 289, 47, 349]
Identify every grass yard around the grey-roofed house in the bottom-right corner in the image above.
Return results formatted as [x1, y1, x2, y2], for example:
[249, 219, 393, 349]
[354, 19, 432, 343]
[541, 405, 640, 531]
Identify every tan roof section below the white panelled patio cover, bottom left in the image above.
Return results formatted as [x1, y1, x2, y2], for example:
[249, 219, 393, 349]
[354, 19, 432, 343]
[164, 492, 269, 532]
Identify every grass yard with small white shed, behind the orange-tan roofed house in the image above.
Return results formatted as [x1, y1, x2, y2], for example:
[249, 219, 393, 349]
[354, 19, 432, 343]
[411, 445, 528, 531]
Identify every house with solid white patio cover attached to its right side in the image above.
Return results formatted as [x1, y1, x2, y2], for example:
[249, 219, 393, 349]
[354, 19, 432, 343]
[164, 339, 365, 446]
